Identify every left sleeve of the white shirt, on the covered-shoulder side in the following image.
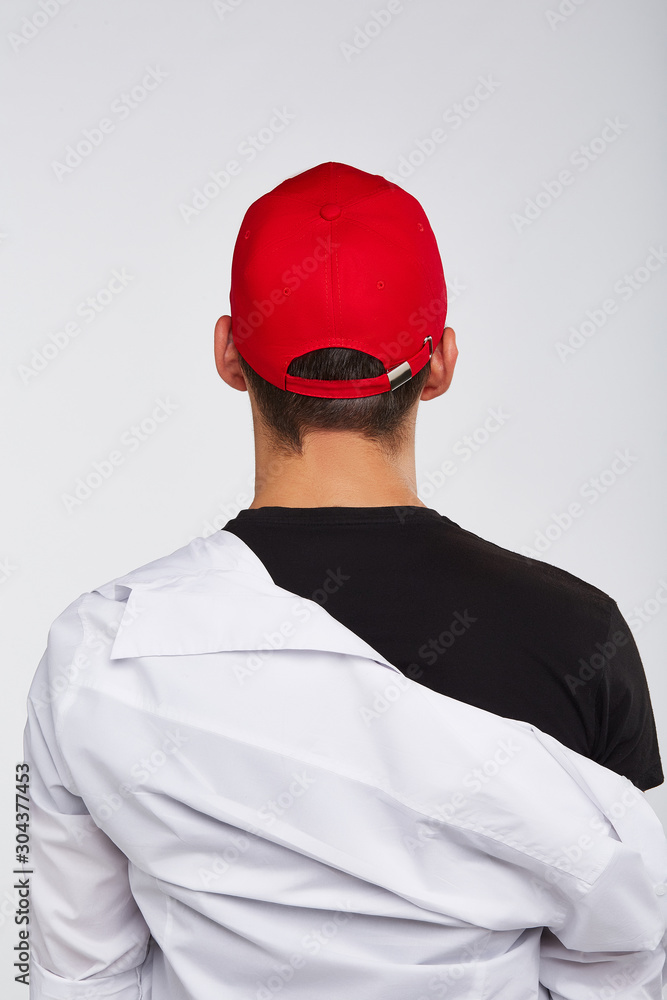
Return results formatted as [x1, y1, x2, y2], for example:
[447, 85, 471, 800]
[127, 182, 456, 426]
[23, 602, 150, 1000]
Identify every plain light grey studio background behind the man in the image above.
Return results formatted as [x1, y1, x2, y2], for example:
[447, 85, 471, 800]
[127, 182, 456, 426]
[0, 0, 667, 997]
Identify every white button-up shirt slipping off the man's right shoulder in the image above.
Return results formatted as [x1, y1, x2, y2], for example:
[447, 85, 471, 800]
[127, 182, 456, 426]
[24, 530, 667, 1000]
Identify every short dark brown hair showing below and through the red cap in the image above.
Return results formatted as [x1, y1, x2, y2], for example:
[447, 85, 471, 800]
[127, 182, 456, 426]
[239, 347, 431, 455]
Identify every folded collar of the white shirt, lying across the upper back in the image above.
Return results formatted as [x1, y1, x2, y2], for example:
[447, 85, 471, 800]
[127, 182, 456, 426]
[94, 529, 401, 674]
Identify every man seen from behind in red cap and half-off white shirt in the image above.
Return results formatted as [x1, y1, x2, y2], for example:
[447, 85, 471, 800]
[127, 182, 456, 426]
[25, 163, 667, 1000]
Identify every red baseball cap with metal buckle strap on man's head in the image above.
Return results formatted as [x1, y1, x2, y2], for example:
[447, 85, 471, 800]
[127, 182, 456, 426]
[230, 163, 447, 399]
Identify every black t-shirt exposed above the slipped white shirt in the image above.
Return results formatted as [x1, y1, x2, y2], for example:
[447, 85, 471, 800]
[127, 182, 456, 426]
[224, 506, 664, 790]
